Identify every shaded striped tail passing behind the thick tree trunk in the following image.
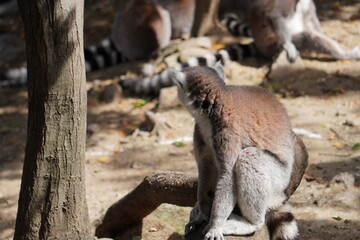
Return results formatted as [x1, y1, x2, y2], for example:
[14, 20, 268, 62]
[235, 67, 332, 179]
[0, 39, 127, 87]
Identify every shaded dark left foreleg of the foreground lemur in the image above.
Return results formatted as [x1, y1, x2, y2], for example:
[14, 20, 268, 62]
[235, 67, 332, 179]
[185, 124, 217, 234]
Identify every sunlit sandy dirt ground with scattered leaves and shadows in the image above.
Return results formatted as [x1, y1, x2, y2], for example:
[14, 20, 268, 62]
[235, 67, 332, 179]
[0, 0, 360, 240]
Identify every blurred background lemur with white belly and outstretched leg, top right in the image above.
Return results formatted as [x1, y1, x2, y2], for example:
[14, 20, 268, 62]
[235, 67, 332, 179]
[242, 0, 360, 62]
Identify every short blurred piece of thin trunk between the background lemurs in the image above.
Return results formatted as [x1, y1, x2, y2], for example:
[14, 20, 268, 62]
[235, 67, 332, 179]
[191, 0, 220, 37]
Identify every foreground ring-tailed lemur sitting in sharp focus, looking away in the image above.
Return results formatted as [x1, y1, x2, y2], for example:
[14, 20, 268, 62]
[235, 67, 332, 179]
[169, 63, 308, 240]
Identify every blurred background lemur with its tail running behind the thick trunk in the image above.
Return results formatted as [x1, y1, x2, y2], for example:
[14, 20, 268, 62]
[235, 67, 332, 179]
[0, 0, 195, 87]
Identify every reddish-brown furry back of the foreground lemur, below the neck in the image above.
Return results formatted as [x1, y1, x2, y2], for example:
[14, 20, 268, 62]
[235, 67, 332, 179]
[222, 86, 292, 153]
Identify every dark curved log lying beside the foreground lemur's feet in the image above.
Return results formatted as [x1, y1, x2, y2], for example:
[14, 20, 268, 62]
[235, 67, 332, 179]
[95, 171, 269, 240]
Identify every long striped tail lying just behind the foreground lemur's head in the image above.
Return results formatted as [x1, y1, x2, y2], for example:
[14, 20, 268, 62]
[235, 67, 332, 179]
[120, 43, 256, 96]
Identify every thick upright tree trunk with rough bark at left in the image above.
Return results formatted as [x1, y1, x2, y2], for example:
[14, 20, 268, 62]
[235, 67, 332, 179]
[14, 0, 92, 240]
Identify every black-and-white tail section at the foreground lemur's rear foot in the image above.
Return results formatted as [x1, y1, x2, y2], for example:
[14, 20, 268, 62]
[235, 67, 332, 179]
[266, 203, 301, 240]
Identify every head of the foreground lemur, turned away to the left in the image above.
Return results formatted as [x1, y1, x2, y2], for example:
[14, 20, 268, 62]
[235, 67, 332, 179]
[169, 62, 225, 115]
